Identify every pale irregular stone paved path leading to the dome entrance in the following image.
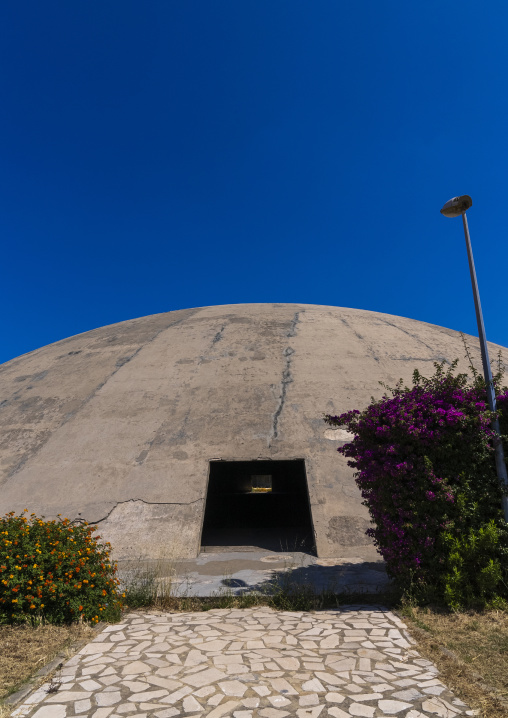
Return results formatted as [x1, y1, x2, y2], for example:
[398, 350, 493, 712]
[12, 606, 474, 718]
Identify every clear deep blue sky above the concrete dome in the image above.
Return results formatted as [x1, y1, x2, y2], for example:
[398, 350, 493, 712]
[0, 0, 508, 361]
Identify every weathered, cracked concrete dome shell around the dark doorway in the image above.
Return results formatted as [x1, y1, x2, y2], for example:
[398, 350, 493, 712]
[0, 304, 508, 560]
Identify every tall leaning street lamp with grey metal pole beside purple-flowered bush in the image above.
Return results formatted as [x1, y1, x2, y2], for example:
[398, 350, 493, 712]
[441, 194, 508, 522]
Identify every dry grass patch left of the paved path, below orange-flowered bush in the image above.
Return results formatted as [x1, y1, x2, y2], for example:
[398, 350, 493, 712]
[0, 624, 95, 704]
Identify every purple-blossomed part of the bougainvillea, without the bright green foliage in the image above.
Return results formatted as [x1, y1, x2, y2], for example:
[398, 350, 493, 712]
[326, 363, 508, 596]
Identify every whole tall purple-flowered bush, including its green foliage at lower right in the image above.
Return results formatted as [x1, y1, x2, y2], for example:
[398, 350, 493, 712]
[325, 362, 508, 608]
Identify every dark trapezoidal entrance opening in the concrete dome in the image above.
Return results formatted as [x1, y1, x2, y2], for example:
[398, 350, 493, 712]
[201, 459, 314, 553]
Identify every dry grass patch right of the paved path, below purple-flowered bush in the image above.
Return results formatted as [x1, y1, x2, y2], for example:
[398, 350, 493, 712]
[401, 606, 508, 718]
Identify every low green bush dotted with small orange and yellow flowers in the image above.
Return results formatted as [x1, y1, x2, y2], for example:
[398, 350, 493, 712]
[0, 510, 122, 623]
